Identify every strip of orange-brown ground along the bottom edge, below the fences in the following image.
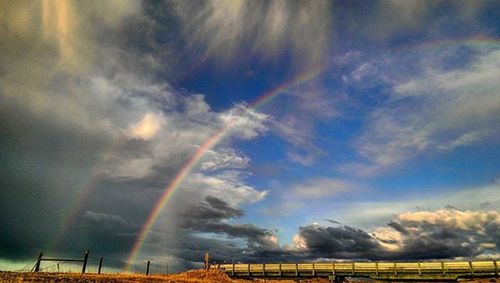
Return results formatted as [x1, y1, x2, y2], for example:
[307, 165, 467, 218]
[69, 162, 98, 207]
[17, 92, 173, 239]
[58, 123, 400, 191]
[0, 270, 500, 283]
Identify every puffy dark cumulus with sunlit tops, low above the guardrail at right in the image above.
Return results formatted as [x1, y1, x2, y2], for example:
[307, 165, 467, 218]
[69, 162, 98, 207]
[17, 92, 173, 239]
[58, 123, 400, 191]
[288, 209, 500, 259]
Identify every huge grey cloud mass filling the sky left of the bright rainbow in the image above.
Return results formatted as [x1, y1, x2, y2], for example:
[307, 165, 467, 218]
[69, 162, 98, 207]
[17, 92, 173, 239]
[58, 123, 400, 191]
[0, 1, 267, 270]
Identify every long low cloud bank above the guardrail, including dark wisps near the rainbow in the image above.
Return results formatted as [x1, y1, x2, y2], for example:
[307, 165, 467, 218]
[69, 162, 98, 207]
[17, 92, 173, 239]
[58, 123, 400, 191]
[175, 208, 500, 262]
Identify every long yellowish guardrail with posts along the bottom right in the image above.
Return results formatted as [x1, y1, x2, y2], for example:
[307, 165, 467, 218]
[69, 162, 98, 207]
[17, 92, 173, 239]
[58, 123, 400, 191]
[211, 260, 500, 281]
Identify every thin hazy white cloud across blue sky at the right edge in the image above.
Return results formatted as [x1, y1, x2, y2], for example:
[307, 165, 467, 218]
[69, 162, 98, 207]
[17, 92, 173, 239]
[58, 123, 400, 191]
[346, 50, 500, 175]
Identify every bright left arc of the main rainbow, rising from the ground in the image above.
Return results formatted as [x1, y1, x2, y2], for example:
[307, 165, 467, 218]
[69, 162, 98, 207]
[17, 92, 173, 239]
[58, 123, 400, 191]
[124, 67, 323, 271]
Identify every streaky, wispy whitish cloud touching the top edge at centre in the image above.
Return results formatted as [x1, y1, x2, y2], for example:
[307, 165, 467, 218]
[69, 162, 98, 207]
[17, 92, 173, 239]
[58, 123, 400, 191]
[177, 0, 331, 67]
